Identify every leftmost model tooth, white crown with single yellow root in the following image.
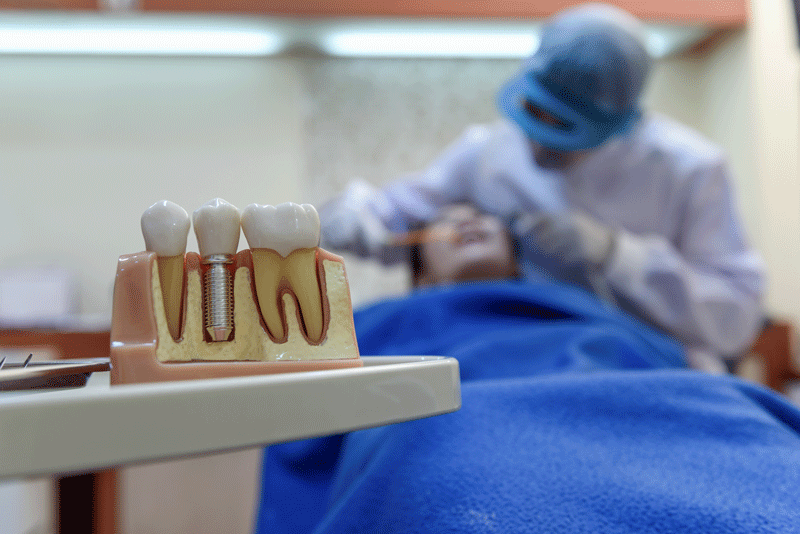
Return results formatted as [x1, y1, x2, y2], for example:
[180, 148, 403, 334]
[142, 200, 190, 339]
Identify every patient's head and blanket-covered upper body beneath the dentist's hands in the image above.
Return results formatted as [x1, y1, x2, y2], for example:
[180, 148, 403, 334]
[355, 204, 685, 380]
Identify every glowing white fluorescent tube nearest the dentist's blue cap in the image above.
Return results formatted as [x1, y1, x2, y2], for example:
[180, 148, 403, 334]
[322, 30, 539, 58]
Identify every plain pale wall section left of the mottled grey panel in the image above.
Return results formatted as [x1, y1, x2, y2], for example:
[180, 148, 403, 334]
[0, 57, 301, 320]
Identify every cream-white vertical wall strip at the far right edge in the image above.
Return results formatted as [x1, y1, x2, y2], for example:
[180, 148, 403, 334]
[748, 0, 800, 324]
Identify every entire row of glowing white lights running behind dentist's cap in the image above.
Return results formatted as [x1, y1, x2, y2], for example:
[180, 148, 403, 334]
[0, 11, 709, 59]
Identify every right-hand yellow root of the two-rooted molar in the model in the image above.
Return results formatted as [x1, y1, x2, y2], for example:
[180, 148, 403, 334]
[284, 248, 323, 343]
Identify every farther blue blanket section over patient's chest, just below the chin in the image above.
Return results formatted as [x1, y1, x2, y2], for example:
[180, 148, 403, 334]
[354, 282, 685, 381]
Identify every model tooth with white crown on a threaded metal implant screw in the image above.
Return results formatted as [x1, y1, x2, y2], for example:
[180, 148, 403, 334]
[193, 198, 239, 341]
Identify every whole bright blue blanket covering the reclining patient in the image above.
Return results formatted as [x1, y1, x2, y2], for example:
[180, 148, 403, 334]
[257, 284, 800, 534]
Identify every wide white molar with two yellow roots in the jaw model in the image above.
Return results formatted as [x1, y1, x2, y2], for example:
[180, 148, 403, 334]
[242, 202, 323, 343]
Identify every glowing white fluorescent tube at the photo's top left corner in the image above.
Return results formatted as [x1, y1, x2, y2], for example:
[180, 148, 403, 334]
[0, 15, 284, 56]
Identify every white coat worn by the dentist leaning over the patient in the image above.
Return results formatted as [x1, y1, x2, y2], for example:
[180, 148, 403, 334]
[320, 115, 764, 362]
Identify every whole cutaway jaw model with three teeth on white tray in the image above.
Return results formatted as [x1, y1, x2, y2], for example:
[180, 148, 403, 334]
[111, 199, 361, 384]
